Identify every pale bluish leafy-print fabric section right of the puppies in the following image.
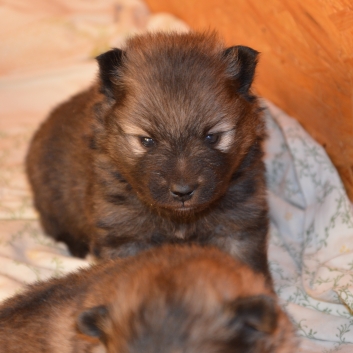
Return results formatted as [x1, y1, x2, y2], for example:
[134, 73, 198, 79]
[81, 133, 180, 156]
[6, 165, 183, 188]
[266, 103, 353, 352]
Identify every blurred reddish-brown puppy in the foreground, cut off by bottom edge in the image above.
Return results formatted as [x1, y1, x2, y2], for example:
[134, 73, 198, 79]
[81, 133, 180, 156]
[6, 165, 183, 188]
[0, 245, 296, 353]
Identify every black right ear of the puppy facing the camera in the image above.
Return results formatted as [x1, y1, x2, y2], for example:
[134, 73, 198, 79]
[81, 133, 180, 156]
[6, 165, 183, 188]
[223, 45, 259, 98]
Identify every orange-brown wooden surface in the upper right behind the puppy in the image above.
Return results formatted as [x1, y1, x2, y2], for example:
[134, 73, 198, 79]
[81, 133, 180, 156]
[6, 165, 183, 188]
[146, 0, 353, 200]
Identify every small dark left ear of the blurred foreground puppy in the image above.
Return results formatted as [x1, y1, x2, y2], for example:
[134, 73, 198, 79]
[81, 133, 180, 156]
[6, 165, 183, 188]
[77, 305, 109, 338]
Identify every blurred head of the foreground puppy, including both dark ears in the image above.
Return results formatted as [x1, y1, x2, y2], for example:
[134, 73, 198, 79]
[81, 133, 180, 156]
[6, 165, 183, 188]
[78, 247, 296, 353]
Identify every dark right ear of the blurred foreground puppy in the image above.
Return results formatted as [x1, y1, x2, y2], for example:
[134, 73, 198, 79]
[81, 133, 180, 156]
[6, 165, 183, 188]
[229, 295, 278, 334]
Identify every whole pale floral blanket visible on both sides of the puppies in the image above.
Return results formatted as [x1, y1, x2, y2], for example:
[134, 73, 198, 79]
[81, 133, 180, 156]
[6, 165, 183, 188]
[0, 0, 353, 353]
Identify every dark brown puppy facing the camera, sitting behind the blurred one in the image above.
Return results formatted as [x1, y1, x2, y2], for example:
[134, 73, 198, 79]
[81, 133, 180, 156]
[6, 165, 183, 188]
[27, 33, 268, 274]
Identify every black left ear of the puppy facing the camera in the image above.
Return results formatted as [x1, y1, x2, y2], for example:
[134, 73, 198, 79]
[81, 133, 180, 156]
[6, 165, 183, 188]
[96, 48, 124, 98]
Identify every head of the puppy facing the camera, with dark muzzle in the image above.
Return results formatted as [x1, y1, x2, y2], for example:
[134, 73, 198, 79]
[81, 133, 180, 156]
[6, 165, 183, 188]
[97, 33, 263, 215]
